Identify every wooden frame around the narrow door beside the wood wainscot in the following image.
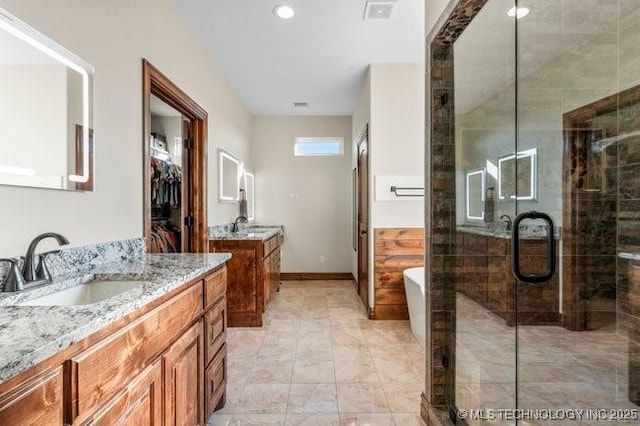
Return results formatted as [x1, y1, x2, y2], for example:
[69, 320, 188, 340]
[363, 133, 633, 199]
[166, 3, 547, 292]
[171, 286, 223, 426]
[355, 123, 374, 319]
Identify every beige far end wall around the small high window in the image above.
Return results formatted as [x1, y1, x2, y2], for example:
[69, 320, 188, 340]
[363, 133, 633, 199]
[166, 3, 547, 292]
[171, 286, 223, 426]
[252, 117, 354, 272]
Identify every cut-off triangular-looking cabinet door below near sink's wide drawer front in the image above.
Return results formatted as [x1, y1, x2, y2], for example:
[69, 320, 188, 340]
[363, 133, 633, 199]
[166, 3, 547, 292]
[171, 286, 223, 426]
[83, 359, 162, 426]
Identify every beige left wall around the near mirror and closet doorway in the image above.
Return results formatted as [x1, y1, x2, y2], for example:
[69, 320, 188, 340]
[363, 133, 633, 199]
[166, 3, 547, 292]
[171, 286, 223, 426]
[0, 0, 251, 256]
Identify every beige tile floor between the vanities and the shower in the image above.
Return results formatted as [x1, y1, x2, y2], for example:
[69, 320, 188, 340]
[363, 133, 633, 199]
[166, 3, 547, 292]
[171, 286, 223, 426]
[208, 281, 425, 426]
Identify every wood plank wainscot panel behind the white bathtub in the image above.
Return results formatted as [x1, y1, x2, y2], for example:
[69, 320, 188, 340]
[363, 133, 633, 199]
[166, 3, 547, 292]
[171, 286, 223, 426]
[370, 228, 424, 320]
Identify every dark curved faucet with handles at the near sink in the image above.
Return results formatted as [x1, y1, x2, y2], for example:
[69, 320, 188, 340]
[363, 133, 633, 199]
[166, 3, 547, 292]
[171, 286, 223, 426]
[0, 232, 69, 292]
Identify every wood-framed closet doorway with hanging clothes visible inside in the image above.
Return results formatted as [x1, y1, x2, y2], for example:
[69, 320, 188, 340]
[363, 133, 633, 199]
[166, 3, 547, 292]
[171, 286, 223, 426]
[142, 59, 208, 253]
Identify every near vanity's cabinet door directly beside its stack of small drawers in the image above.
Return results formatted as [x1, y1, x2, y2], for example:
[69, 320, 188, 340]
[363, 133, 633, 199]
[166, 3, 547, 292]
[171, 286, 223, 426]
[163, 321, 204, 426]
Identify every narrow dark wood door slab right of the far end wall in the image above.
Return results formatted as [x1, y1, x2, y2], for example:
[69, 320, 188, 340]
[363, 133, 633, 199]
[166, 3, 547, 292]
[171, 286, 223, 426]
[358, 127, 369, 309]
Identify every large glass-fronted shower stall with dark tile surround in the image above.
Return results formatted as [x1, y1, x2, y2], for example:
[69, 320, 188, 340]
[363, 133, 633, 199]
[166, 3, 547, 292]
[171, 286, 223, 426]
[422, 0, 640, 425]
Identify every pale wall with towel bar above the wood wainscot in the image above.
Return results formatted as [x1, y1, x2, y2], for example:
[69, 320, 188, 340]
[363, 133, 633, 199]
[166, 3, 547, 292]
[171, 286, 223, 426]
[351, 64, 425, 306]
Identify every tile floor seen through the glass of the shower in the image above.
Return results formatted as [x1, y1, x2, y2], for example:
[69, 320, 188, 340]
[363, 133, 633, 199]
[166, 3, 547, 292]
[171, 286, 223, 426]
[456, 293, 640, 425]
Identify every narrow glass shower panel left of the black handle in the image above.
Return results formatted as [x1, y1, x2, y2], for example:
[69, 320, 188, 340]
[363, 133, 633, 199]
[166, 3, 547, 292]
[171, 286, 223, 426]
[452, 0, 517, 424]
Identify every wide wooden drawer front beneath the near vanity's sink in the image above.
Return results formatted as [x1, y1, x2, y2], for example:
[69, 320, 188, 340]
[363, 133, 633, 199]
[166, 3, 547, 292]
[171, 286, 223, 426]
[69, 283, 202, 423]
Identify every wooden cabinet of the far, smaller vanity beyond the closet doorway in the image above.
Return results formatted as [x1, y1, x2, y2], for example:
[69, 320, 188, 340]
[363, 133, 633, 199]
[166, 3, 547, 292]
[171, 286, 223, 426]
[209, 234, 282, 327]
